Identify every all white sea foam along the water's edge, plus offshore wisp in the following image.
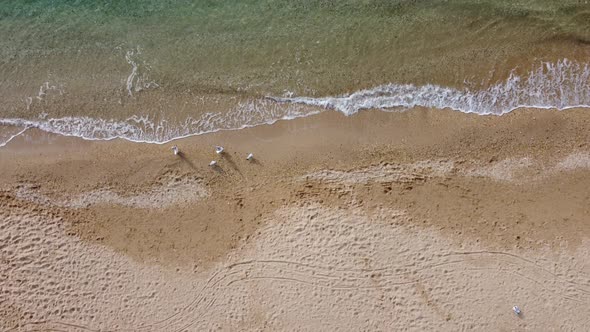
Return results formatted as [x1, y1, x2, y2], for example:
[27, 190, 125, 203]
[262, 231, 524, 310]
[0, 58, 590, 143]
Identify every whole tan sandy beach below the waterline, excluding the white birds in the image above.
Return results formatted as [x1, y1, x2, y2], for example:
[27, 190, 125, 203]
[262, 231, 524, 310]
[0, 109, 590, 331]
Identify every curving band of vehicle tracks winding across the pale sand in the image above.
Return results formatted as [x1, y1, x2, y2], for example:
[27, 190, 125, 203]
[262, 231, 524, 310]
[9, 251, 590, 332]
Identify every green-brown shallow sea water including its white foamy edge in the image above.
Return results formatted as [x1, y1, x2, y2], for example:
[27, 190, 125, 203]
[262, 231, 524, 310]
[0, 0, 590, 146]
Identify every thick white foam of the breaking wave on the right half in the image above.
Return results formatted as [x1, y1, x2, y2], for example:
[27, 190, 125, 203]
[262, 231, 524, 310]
[271, 59, 590, 115]
